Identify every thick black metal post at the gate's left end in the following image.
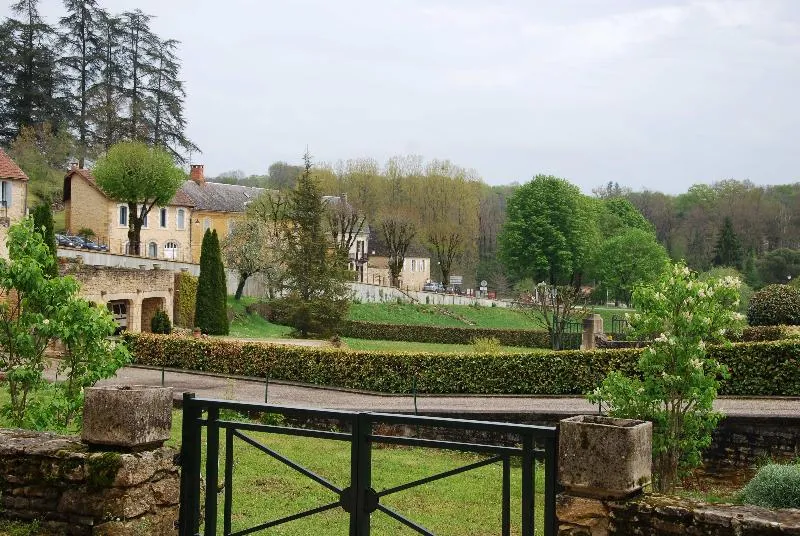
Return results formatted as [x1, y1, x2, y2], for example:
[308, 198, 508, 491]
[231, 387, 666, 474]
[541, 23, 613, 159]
[178, 393, 202, 536]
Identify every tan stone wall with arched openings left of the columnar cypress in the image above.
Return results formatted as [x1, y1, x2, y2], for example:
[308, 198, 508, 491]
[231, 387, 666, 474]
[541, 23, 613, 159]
[61, 263, 175, 332]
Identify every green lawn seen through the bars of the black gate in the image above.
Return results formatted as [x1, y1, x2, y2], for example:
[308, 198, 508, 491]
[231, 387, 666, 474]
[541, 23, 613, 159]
[170, 412, 544, 536]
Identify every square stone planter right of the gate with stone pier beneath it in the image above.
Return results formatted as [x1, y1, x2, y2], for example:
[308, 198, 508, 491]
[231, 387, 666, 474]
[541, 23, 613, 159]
[556, 415, 653, 536]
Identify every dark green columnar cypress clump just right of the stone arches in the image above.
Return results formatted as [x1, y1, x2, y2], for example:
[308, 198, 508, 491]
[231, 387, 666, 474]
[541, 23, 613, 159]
[194, 229, 229, 335]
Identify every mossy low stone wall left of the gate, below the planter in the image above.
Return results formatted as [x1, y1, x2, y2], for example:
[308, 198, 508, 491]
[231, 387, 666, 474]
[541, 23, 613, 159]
[0, 430, 180, 536]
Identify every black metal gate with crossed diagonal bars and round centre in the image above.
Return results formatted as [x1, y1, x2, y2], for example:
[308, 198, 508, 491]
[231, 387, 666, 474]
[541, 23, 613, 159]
[180, 393, 557, 536]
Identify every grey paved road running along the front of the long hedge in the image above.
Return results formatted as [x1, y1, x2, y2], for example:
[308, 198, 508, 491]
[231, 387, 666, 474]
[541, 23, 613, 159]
[47, 367, 800, 418]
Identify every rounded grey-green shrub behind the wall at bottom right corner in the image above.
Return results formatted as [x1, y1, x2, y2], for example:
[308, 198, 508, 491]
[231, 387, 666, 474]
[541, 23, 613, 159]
[742, 464, 800, 508]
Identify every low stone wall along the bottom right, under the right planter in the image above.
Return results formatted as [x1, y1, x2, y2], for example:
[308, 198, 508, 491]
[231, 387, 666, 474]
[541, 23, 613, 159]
[556, 493, 800, 536]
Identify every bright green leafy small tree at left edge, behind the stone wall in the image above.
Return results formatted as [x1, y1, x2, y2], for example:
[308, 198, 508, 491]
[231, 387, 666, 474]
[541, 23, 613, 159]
[0, 218, 127, 426]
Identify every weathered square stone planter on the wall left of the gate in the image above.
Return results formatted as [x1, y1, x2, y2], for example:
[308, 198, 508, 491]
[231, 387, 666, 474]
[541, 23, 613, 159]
[81, 385, 172, 450]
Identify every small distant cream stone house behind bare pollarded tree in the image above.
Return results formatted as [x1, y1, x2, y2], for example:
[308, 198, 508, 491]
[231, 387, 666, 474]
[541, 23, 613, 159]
[363, 229, 431, 290]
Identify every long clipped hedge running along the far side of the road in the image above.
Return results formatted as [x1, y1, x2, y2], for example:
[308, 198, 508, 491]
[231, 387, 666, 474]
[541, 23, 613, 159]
[126, 334, 800, 396]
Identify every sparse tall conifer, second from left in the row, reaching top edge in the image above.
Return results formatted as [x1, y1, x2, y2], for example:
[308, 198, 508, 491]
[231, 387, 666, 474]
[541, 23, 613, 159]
[59, 0, 103, 167]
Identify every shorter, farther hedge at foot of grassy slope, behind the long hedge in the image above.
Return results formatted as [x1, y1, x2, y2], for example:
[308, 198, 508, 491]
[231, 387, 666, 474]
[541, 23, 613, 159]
[338, 320, 552, 348]
